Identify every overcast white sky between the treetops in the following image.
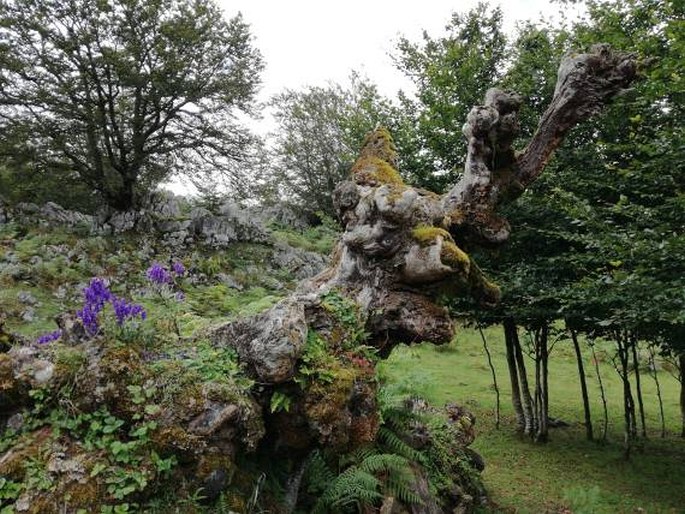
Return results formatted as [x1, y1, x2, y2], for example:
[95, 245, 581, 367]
[220, 0, 576, 100]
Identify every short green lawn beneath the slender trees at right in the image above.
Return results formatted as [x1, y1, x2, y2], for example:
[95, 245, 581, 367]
[381, 329, 685, 514]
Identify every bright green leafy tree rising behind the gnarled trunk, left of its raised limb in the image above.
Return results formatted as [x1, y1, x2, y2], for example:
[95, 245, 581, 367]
[395, 3, 506, 192]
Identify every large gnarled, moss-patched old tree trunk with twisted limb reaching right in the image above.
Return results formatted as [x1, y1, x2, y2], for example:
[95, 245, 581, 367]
[0, 45, 636, 508]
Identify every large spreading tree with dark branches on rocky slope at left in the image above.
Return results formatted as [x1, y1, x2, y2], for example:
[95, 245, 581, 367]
[0, 0, 263, 209]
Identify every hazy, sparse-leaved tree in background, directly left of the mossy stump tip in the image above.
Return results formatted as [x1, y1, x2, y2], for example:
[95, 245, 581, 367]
[267, 74, 396, 216]
